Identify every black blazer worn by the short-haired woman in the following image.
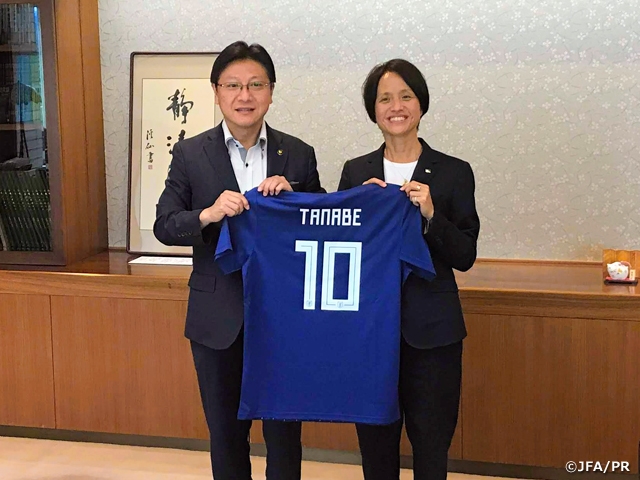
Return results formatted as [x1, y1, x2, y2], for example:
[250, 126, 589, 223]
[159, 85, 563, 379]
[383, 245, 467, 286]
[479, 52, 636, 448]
[338, 139, 480, 348]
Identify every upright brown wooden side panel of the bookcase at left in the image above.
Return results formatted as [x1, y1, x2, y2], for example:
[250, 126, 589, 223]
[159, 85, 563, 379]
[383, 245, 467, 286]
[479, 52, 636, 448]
[55, 0, 108, 263]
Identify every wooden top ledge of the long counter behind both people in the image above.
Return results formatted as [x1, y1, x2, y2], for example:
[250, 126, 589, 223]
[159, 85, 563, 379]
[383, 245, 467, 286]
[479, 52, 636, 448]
[6, 250, 640, 304]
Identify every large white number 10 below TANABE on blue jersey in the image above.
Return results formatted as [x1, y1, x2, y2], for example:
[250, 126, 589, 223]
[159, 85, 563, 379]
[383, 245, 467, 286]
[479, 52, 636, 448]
[296, 240, 362, 312]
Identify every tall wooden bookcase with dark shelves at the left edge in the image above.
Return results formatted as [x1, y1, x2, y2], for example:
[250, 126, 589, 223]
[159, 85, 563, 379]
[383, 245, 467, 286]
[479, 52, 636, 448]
[0, 0, 108, 265]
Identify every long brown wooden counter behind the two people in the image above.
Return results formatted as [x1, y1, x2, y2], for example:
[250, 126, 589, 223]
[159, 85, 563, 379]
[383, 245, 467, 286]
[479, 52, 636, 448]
[0, 252, 640, 472]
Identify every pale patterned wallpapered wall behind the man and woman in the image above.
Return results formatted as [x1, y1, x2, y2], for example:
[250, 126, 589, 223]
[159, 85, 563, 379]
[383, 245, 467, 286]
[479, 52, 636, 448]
[99, 0, 640, 260]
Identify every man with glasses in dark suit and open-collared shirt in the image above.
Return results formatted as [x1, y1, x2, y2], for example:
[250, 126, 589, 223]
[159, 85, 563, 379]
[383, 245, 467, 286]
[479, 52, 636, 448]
[154, 42, 324, 480]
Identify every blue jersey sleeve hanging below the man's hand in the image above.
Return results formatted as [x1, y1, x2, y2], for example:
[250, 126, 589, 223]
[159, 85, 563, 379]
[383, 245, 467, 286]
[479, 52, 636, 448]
[215, 191, 258, 274]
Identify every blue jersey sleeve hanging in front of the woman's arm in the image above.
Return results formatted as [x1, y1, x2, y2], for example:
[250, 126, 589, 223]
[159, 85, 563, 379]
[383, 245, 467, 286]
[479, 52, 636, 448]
[400, 202, 436, 281]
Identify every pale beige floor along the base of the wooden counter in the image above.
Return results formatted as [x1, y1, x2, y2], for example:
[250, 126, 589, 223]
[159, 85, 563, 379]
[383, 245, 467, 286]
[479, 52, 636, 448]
[0, 437, 500, 480]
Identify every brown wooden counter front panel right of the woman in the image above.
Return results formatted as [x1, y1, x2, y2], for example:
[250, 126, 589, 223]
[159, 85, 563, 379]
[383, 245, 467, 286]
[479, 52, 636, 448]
[462, 315, 640, 471]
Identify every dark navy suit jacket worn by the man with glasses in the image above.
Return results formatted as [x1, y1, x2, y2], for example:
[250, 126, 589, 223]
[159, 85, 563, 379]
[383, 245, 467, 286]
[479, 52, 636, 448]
[153, 124, 324, 349]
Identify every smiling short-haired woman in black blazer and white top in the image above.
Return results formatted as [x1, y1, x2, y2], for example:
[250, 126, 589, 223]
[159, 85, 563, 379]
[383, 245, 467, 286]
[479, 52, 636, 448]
[338, 59, 480, 480]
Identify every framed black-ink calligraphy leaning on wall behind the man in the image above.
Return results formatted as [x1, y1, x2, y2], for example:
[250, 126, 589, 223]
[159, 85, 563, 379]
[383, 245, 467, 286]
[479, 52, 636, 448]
[127, 52, 222, 255]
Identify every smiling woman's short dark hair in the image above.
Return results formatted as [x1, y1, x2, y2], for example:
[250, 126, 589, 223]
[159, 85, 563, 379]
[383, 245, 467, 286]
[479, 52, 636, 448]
[362, 58, 429, 123]
